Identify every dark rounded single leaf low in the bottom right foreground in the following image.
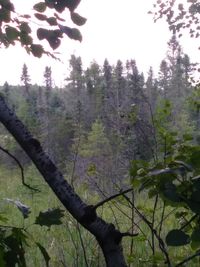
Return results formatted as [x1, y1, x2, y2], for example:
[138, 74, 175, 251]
[166, 229, 190, 247]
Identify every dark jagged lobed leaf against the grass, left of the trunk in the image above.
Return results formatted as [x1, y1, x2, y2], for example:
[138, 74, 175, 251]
[35, 208, 64, 227]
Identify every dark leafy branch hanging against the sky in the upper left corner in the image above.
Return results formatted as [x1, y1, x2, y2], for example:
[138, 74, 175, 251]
[0, 0, 86, 58]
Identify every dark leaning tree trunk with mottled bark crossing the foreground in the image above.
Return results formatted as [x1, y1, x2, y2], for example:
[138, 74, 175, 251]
[0, 96, 126, 267]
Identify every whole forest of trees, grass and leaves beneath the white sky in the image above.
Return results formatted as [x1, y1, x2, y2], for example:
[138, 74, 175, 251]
[0, 1, 200, 267]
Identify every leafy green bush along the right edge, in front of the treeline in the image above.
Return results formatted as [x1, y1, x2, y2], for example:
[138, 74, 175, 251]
[130, 101, 200, 266]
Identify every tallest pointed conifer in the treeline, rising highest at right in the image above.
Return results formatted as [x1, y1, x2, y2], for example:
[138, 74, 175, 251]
[159, 35, 192, 134]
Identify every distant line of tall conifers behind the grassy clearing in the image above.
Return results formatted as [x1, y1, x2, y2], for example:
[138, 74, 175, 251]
[0, 36, 200, 192]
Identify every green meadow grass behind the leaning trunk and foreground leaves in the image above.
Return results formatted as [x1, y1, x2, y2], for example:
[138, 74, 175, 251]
[0, 167, 200, 267]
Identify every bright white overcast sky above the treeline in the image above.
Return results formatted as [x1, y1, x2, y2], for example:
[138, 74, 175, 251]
[0, 0, 199, 86]
